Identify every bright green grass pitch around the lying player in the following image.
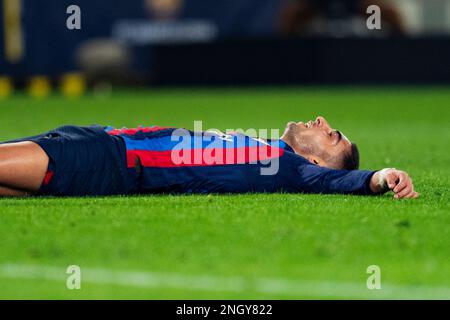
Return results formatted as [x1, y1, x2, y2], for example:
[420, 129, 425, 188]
[0, 87, 450, 299]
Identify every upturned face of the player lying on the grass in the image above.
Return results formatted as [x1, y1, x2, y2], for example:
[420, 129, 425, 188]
[285, 117, 351, 167]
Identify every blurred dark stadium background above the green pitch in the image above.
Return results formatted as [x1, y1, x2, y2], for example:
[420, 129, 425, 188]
[0, 0, 450, 96]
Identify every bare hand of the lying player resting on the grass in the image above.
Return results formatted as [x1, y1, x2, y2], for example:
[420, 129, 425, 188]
[370, 168, 419, 199]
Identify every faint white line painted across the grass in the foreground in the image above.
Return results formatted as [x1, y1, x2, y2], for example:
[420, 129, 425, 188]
[0, 264, 450, 299]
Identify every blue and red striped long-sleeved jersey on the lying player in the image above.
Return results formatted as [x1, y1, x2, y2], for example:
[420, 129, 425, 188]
[105, 126, 374, 194]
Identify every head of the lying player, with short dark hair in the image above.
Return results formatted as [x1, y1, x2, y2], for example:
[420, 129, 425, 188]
[281, 117, 359, 170]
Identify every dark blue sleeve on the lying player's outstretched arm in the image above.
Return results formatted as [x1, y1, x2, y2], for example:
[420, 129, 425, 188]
[294, 164, 375, 195]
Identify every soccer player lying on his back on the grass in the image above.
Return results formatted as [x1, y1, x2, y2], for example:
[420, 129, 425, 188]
[0, 117, 418, 199]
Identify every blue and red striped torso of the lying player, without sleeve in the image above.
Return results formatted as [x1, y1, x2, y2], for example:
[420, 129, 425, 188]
[105, 126, 304, 193]
